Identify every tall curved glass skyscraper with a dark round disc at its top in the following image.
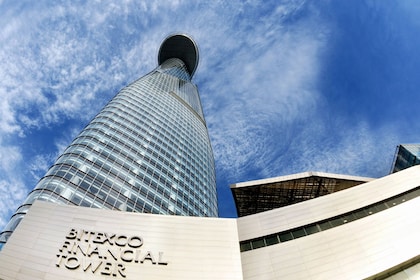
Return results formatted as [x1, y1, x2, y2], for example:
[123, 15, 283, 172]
[0, 34, 218, 246]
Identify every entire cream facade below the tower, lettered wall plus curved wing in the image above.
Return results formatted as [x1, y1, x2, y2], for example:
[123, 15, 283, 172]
[0, 166, 420, 280]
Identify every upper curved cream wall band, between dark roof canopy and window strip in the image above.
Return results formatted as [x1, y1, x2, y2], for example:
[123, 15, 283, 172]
[238, 165, 420, 240]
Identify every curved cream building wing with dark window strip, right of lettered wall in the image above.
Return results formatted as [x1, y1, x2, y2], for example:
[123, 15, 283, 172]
[233, 166, 420, 280]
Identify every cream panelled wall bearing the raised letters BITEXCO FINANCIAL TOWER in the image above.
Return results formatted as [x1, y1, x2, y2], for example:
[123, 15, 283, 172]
[0, 202, 242, 280]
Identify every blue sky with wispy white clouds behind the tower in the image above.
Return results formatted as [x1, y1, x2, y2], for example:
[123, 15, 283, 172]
[0, 0, 420, 225]
